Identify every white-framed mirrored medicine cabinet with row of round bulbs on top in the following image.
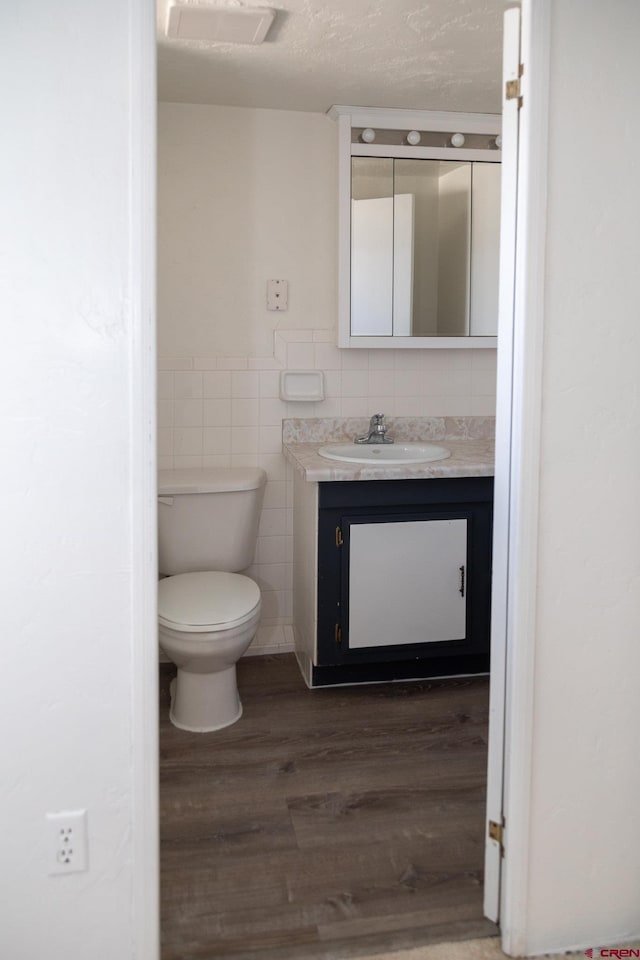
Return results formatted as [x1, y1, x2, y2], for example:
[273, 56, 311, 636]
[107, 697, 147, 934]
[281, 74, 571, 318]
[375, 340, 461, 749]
[329, 106, 501, 348]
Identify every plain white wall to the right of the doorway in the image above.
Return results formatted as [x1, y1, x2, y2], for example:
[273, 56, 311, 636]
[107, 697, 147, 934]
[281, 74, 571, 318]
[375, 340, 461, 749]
[520, 0, 640, 955]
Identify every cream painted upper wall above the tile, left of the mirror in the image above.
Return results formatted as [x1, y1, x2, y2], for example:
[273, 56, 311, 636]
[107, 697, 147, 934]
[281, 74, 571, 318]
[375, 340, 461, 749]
[158, 103, 337, 357]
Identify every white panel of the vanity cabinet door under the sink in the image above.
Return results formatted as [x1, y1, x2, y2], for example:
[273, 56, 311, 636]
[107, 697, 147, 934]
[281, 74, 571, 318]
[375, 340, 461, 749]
[349, 520, 467, 649]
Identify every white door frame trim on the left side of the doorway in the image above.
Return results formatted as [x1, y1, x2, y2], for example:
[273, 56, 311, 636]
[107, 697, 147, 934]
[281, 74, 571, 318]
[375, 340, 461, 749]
[130, 0, 160, 960]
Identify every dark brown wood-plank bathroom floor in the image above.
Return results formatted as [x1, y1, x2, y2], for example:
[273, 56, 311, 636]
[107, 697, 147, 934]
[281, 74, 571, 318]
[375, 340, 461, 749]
[160, 654, 496, 960]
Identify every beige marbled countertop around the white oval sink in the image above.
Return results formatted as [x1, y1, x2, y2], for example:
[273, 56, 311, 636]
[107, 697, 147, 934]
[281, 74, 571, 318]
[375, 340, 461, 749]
[283, 437, 494, 483]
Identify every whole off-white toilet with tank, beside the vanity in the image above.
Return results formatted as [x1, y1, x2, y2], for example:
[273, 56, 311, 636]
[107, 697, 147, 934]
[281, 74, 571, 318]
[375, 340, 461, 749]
[158, 467, 266, 733]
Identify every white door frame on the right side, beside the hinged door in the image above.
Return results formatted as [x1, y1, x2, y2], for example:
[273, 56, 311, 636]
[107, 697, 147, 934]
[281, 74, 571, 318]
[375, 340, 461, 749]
[496, 0, 552, 956]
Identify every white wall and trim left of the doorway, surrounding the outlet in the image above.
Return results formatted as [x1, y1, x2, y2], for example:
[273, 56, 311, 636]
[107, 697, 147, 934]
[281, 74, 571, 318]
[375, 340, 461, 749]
[0, 0, 157, 960]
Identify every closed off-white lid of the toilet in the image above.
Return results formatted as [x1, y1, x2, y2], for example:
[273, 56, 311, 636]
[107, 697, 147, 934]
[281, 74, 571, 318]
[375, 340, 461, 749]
[158, 571, 260, 627]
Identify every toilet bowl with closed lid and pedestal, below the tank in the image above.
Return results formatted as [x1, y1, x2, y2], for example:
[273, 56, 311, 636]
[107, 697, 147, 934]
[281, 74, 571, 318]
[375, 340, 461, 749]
[158, 571, 261, 733]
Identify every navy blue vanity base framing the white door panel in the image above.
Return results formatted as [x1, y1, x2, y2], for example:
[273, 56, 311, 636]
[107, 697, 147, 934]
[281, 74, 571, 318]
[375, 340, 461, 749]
[311, 477, 493, 687]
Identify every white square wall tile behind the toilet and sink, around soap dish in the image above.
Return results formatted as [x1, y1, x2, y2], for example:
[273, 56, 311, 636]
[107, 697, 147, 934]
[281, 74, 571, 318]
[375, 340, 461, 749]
[158, 330, 496, 654]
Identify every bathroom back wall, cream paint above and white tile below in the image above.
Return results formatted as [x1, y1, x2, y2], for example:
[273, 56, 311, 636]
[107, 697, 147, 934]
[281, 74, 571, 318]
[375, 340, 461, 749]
[158, 103, 495, 653]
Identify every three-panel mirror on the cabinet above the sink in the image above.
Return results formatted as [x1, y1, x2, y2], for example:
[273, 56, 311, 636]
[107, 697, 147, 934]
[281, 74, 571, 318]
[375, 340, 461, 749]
[350, 156, 500, 337]
